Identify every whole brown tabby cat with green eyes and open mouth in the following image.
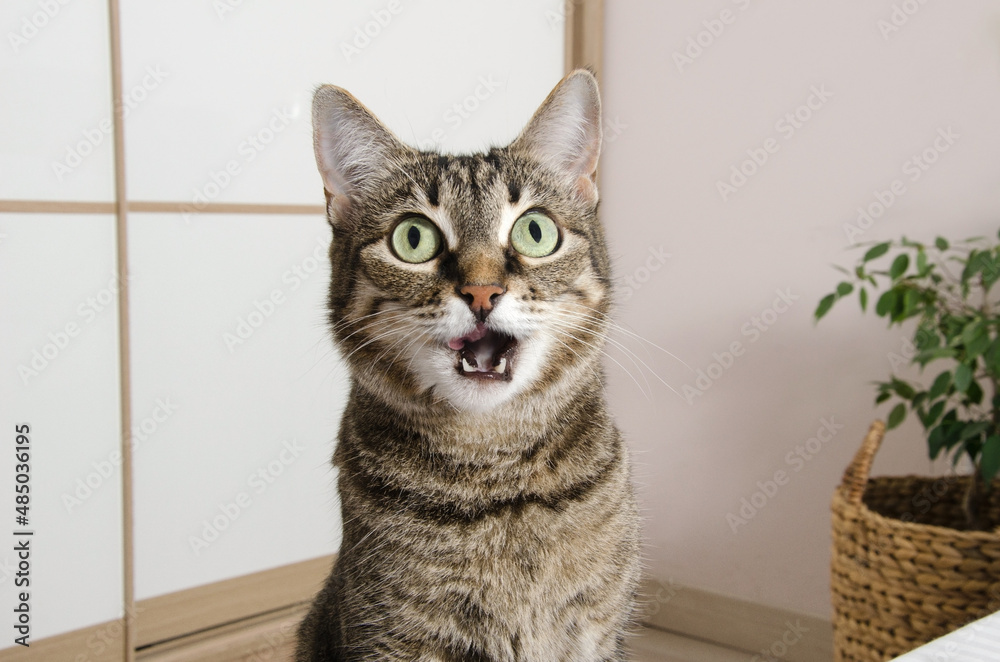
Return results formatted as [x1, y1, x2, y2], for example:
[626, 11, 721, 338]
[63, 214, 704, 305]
[296, 71, 639, 662]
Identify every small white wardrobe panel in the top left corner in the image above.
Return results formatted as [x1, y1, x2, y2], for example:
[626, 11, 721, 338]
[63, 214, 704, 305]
[0, 0, 114, 201]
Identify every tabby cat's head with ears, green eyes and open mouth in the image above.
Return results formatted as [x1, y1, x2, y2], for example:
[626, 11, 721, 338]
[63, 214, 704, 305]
[313, 71, 610, 412]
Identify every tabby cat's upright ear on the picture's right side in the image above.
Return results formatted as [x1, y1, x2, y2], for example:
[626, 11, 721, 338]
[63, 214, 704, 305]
[511, 69, 601, 202]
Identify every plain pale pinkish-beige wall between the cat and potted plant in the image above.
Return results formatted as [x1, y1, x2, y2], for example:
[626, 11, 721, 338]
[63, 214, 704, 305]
[601, 0, 1000, 617]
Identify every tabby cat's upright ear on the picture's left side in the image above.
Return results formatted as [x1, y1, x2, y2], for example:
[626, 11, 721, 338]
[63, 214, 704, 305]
[313, 85, 407, 219]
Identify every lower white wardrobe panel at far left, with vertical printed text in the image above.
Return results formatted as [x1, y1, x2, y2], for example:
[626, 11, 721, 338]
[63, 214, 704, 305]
[0, 214, 122, 644]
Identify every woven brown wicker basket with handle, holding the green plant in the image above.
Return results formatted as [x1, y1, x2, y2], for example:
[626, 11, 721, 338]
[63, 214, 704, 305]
[831, 421, 1000, 662]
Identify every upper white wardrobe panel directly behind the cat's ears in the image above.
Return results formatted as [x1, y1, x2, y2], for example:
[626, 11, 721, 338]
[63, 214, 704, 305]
[122, 0, 563, 204]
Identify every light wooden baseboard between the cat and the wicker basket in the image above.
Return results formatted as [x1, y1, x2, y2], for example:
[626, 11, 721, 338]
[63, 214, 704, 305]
[641, 579, 833, 662]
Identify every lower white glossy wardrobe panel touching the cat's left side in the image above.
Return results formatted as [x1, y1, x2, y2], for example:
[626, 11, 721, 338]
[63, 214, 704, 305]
[129, 214, 346, 600]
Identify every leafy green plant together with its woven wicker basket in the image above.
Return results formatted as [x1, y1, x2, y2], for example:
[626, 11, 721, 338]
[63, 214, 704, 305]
[815, 235, 1000, 660]
